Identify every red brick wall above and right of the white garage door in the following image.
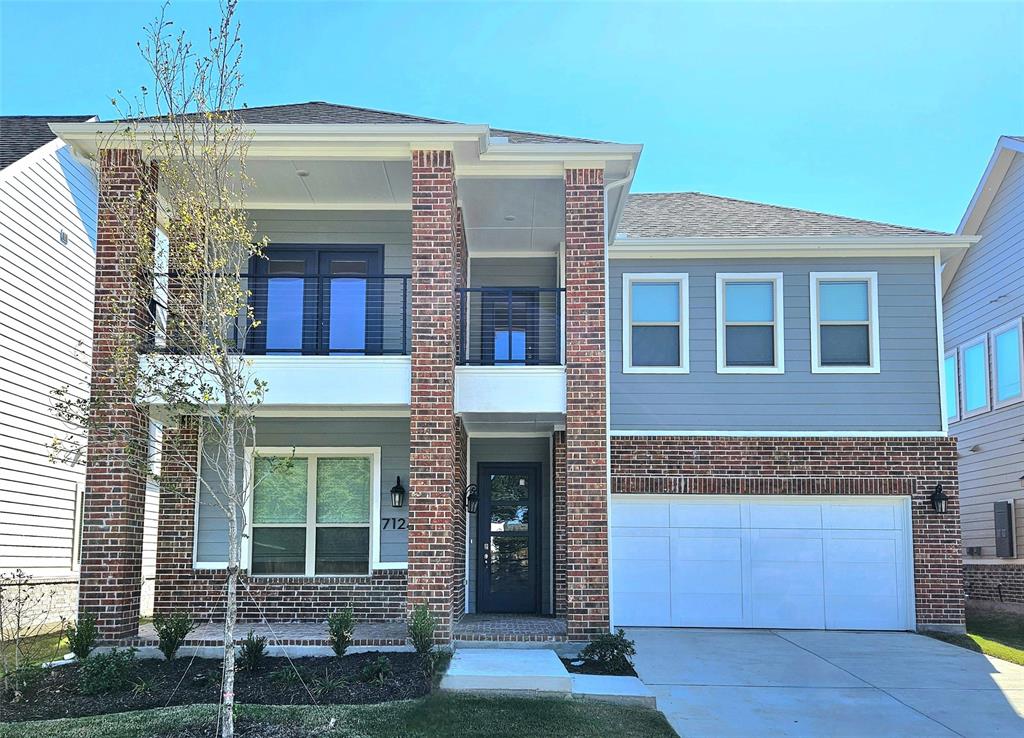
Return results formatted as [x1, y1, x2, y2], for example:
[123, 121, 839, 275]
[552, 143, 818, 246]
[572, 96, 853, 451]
[611, 436, 964, 627]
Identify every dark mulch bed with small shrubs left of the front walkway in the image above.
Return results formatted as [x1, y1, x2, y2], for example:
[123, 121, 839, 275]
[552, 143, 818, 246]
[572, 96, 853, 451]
[0, 652, 430, 722]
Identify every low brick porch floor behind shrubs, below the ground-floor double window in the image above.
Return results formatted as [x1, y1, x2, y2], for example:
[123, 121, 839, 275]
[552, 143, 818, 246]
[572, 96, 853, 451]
[127, 621, 409, 646]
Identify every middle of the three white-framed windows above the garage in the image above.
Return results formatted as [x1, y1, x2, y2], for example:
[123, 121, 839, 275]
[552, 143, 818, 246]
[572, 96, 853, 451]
[715, 273, 785, 374]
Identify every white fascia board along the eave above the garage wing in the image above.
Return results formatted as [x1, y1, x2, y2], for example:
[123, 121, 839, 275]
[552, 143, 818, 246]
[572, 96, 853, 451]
[611, 234, 978, 259]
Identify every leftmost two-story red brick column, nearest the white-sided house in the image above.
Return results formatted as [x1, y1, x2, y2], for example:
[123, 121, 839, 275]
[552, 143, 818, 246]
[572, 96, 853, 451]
[79, 149, 157, 641]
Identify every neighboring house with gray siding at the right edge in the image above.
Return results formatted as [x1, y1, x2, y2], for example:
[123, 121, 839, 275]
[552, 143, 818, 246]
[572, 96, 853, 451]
[943, 136, 1024, 604]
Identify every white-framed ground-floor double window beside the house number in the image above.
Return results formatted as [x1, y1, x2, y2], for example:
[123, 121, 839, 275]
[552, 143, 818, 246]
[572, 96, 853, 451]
[249, 448, 380, 576]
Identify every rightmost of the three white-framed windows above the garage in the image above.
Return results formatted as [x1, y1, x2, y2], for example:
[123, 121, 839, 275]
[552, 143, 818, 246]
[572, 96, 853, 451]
[810, 271, 880, 374]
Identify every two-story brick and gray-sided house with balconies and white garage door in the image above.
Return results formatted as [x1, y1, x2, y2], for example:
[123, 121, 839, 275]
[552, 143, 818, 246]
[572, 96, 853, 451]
[54, 102, 970, 640]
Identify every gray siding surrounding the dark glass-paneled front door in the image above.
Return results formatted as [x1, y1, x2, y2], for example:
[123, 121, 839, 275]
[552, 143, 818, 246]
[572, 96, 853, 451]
[466, 437, 552, 613]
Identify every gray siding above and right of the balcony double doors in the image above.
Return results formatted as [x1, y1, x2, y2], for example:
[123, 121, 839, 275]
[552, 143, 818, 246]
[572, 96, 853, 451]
[250, 210, 413, 274]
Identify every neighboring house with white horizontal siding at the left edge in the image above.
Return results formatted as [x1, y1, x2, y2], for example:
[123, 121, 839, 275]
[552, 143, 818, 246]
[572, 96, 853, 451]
[0, 116, 96, 620]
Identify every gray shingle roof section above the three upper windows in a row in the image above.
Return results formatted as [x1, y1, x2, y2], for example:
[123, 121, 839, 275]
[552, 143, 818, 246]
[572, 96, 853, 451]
[616, 192, 945, 238]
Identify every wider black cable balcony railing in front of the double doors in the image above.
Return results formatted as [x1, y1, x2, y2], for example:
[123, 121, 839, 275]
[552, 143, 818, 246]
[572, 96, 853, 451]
[151, 274, 411, 356]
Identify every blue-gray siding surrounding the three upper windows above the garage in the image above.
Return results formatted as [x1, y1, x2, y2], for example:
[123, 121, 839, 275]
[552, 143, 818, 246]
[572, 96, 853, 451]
[608, 257, 941, 432]
